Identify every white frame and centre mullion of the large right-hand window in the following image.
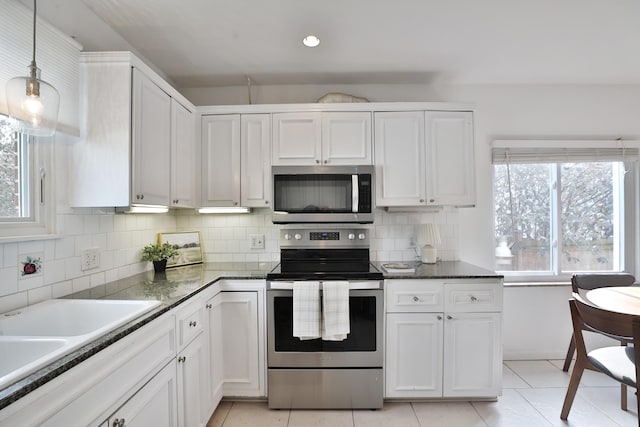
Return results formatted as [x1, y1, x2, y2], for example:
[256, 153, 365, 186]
[492, 140, 640, 283]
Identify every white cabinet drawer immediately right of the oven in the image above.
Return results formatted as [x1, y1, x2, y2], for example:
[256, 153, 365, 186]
[385, 280, 443, 313]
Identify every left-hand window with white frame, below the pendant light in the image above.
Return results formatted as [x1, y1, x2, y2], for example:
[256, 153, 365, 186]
[0, 114, 53, 238]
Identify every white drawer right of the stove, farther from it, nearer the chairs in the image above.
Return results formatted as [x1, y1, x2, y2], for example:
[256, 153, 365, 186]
[444, 280, 502, 313]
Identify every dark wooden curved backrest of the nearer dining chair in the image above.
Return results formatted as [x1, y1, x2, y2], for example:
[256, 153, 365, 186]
[569, 292, 640, 344]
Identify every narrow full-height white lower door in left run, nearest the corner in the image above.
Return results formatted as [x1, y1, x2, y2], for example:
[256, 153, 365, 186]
[206, 294, 224, 412]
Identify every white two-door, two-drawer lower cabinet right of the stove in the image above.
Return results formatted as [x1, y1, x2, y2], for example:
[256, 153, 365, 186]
[385, 279, 502, 398]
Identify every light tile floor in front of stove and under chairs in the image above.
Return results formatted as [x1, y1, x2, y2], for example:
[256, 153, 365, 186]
[207, 360, 638, 427]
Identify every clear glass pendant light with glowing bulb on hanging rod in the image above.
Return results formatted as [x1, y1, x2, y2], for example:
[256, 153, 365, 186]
[6, 0, 60, 136]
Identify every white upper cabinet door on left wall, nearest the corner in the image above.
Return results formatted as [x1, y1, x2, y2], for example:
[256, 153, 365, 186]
[171, 99, 196, 207]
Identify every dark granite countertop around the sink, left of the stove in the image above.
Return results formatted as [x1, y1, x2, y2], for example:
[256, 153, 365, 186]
[0, 262, 276, 410]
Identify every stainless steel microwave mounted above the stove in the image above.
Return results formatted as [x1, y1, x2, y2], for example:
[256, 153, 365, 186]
[272, 166, 375, 224]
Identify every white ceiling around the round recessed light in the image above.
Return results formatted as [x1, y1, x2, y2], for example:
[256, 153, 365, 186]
[21, 0, 640, 87]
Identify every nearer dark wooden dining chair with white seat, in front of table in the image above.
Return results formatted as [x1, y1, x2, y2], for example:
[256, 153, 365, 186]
[560, 293, 640, 426]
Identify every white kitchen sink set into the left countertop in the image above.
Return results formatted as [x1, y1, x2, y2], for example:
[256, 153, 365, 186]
[0, 299, 160, 389]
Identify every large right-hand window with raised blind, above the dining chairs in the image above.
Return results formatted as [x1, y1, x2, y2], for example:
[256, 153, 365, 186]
[493, 141, 637, 280]
